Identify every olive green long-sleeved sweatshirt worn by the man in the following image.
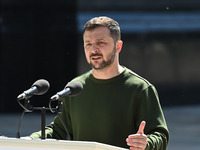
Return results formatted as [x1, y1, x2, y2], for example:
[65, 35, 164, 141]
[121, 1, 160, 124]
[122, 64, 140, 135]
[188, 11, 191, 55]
[31, 68, 169, 150]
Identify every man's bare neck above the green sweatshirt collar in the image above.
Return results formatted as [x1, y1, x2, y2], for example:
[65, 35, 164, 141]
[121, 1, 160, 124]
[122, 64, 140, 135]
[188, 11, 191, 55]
[92, 65, 124, 79]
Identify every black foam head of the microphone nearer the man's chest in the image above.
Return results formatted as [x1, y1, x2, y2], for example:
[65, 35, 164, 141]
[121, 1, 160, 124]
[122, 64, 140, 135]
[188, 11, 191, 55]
[65, 81, 83, 96]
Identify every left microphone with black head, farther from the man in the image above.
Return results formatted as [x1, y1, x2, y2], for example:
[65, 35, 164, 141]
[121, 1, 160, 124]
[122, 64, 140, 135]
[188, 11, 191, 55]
[17, 79, 50, 100]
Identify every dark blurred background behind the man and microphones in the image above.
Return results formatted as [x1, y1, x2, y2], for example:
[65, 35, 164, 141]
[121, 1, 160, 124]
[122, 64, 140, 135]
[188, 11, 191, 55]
[0, 0, 200, 150]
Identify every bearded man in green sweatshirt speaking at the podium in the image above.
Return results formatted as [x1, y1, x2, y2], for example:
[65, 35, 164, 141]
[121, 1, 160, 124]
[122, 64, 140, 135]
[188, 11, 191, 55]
[31, 17, 169, 150]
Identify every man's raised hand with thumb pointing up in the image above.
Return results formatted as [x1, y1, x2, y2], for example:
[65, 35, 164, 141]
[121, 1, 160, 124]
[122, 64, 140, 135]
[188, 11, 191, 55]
[126, 121, 147, 150]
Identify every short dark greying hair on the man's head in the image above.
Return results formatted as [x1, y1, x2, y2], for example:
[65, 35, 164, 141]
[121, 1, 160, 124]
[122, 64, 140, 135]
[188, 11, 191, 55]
[83, 16, 121, 42]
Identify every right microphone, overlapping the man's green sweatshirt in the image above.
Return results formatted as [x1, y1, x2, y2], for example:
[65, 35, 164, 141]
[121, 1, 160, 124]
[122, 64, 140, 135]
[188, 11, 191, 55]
[51, 81, 83, 101]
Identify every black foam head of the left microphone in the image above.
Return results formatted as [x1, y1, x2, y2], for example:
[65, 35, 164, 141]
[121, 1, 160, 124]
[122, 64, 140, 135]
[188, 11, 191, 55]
[31, 79, 50, 95]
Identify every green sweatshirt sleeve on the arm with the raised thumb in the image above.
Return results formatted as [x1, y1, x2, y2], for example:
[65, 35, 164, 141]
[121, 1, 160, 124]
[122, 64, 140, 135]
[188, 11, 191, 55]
[136, 85, 169, 150]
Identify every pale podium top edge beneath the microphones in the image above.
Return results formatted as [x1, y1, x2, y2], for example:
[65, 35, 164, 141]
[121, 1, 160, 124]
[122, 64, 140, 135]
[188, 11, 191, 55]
[0, 137, 127, 150]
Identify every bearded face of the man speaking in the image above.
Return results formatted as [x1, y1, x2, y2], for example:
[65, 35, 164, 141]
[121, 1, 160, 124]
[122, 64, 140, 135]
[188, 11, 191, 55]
[83, 27, 116, 70]
